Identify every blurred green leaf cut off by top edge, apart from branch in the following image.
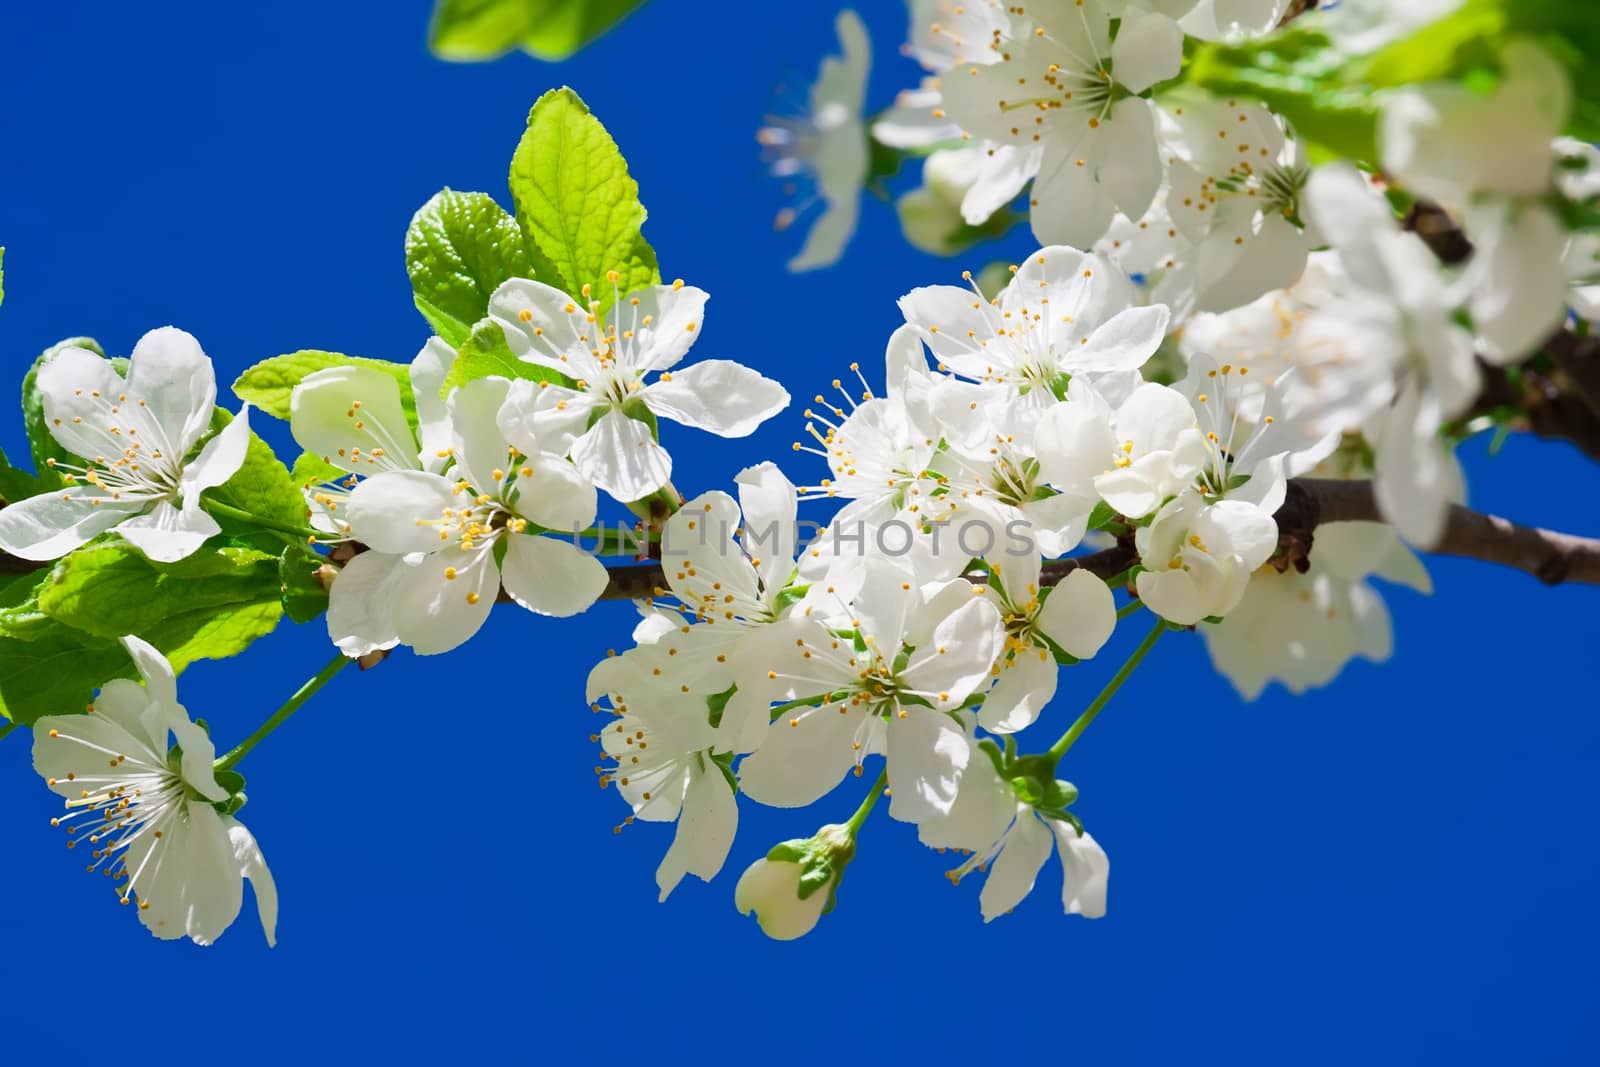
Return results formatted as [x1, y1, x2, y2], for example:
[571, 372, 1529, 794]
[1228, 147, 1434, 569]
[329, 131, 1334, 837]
[427, 0, 645, 61]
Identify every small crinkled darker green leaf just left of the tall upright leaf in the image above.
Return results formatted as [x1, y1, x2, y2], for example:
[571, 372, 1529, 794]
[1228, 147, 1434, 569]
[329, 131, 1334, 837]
[405, 189, 533, 347]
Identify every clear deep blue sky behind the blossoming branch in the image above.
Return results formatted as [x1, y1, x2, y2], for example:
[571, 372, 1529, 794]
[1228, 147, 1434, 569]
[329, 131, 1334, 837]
[0, 0, 1600, 1065]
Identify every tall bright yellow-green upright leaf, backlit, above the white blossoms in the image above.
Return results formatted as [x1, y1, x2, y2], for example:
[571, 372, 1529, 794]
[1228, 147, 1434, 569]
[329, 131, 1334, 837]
[510, 88, 661, 307]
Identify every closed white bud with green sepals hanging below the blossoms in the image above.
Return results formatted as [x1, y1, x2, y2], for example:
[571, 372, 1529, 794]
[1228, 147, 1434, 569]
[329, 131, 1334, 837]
[733, 825, 856, 941]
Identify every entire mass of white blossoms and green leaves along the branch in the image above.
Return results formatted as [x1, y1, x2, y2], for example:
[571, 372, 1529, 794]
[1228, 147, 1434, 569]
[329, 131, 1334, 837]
[12, 10, 1600, 944]
